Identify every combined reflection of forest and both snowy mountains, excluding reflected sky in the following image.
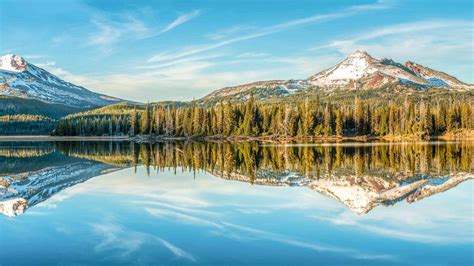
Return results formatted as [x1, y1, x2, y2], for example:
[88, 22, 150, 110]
[0, 142, 474, 216]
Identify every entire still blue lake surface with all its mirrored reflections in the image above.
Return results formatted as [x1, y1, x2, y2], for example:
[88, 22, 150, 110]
[0, 142, 474, 265]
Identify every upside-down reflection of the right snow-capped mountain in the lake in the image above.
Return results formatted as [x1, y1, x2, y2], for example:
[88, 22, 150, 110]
[218, 171, 474, 214]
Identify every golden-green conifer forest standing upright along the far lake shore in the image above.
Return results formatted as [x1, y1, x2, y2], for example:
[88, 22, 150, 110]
[53, 96, 474, 139]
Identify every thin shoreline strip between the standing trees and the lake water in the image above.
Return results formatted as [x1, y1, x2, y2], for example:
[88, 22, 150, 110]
[0, 135, 474, 143]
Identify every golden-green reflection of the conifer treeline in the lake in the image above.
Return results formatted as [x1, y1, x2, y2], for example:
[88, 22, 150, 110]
[42, 142, 473, 179]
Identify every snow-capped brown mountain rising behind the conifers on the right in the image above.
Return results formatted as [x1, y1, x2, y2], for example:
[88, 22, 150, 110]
[203, 51, 474, 100]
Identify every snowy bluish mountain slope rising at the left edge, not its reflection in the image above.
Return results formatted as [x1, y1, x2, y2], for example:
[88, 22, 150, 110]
[0, 54, 122, 108]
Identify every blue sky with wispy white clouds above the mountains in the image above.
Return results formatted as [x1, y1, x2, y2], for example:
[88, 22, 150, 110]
[0, 0, 474, 101]
